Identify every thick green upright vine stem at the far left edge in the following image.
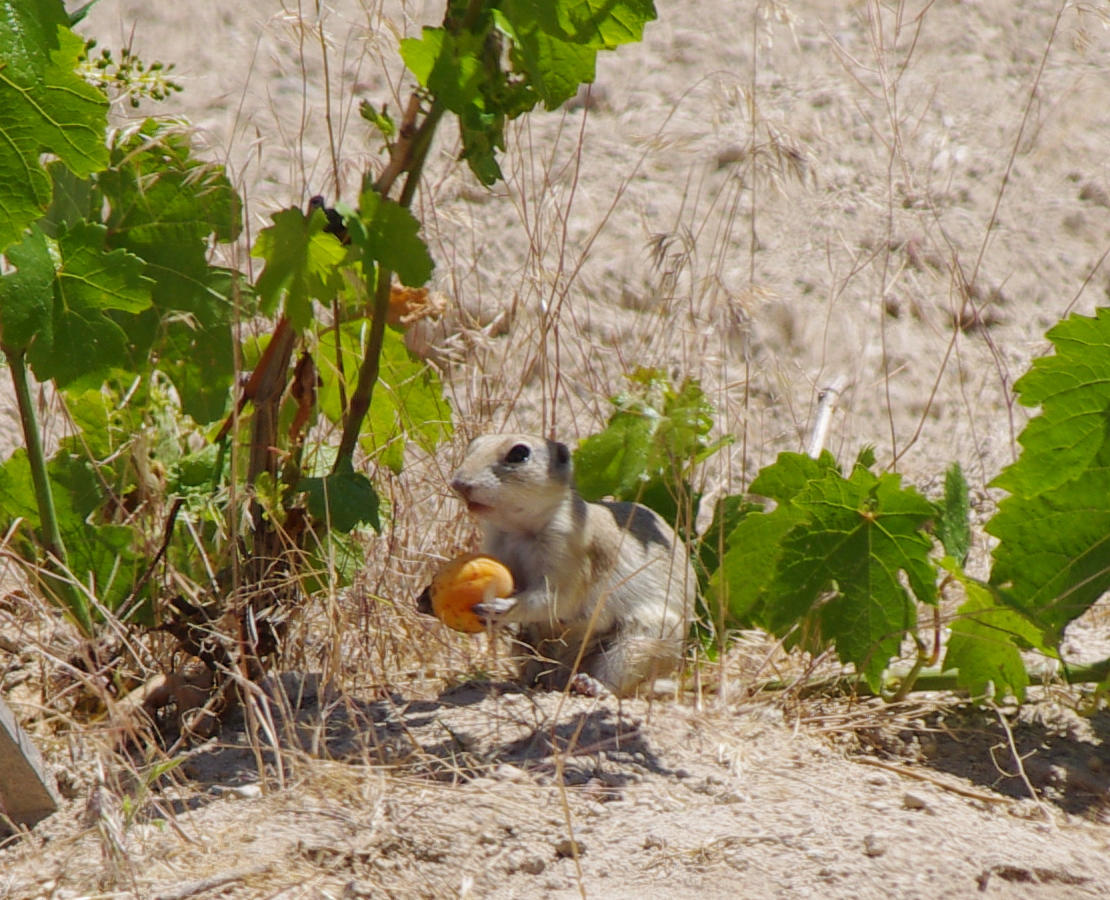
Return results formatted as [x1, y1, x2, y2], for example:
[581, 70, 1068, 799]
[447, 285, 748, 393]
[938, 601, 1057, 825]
[0, 346, 92, 635]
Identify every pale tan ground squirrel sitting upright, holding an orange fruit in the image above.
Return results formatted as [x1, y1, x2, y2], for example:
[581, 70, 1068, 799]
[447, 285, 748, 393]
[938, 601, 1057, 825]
[451, 434, 695, 696]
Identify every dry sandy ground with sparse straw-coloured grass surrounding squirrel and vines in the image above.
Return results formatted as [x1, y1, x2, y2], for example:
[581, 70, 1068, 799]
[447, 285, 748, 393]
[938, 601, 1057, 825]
[0, 0, 1110, 898]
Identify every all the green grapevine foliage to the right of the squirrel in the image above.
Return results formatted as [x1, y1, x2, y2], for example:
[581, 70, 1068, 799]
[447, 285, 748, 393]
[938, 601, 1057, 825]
[579, 309, 1110, 699]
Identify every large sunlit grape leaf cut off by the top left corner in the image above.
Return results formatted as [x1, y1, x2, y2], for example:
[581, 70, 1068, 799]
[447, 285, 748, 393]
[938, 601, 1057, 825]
[0, 0, 108, 250]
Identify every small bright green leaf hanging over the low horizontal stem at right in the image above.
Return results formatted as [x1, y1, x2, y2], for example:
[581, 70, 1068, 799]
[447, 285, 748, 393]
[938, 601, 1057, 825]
[941, 559, 1042, 700]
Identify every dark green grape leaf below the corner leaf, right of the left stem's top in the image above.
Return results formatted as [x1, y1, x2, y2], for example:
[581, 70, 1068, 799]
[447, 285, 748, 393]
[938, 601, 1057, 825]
[20, 222, 150, 387]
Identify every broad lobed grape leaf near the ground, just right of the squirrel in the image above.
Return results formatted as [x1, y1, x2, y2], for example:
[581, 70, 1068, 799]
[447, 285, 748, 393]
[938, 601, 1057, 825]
[728, 453, 937, 690]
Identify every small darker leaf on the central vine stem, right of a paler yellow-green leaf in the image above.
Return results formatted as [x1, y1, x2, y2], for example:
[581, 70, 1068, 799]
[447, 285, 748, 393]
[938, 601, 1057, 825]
[346, 189, 433, 287]
